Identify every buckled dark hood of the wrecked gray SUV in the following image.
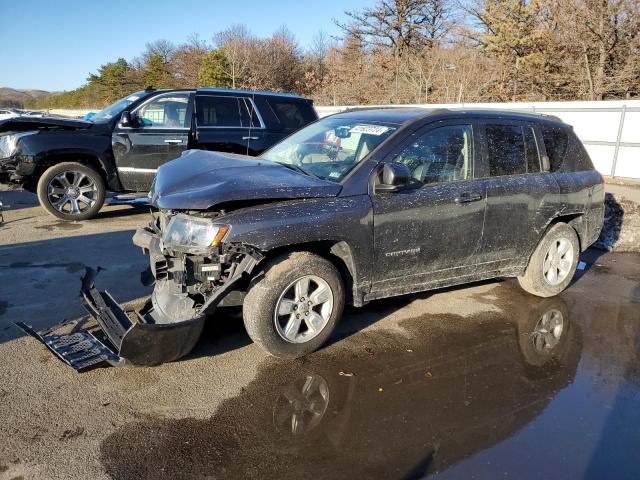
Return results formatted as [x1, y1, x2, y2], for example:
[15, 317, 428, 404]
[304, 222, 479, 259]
[149, 150, 342, 210]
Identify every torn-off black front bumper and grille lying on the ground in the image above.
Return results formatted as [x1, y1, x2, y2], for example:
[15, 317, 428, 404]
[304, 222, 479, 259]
[16, 269, 205, 371]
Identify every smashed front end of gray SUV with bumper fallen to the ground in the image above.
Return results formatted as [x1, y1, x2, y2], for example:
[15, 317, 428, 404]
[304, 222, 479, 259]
[17, 215, 263, 371]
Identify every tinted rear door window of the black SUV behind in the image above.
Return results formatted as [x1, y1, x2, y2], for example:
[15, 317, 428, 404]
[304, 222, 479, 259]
[196, 95, 260, 128]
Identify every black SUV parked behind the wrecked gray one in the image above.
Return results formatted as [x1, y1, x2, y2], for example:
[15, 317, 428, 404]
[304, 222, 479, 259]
[0, 88, 318, 220]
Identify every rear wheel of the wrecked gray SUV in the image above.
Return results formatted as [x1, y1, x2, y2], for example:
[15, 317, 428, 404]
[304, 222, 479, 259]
[518, 223, 580, 297]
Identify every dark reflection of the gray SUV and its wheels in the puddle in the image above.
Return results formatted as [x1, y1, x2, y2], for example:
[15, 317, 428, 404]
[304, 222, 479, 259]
[273, 297, 580, 458]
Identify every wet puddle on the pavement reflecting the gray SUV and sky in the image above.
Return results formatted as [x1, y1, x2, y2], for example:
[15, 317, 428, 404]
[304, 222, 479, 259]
[101, 285, 640, 479]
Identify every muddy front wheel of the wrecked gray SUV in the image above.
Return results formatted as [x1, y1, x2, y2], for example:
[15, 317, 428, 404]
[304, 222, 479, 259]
[243, 252, 344, 358]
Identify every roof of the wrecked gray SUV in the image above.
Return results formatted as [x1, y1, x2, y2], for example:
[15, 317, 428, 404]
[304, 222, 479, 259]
[332, 107, 565, 125]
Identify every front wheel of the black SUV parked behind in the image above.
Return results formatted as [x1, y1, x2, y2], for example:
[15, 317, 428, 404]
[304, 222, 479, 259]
[37, 162, 105, 221]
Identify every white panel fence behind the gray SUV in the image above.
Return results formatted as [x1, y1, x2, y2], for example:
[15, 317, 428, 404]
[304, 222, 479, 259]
[316, 100, 640, 179]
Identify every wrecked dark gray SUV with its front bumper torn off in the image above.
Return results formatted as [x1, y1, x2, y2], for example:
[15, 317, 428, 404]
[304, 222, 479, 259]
[17, 108, 604, 369]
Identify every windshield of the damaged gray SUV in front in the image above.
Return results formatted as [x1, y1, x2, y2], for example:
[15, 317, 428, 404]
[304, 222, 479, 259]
[260, 117, 397, 182]
